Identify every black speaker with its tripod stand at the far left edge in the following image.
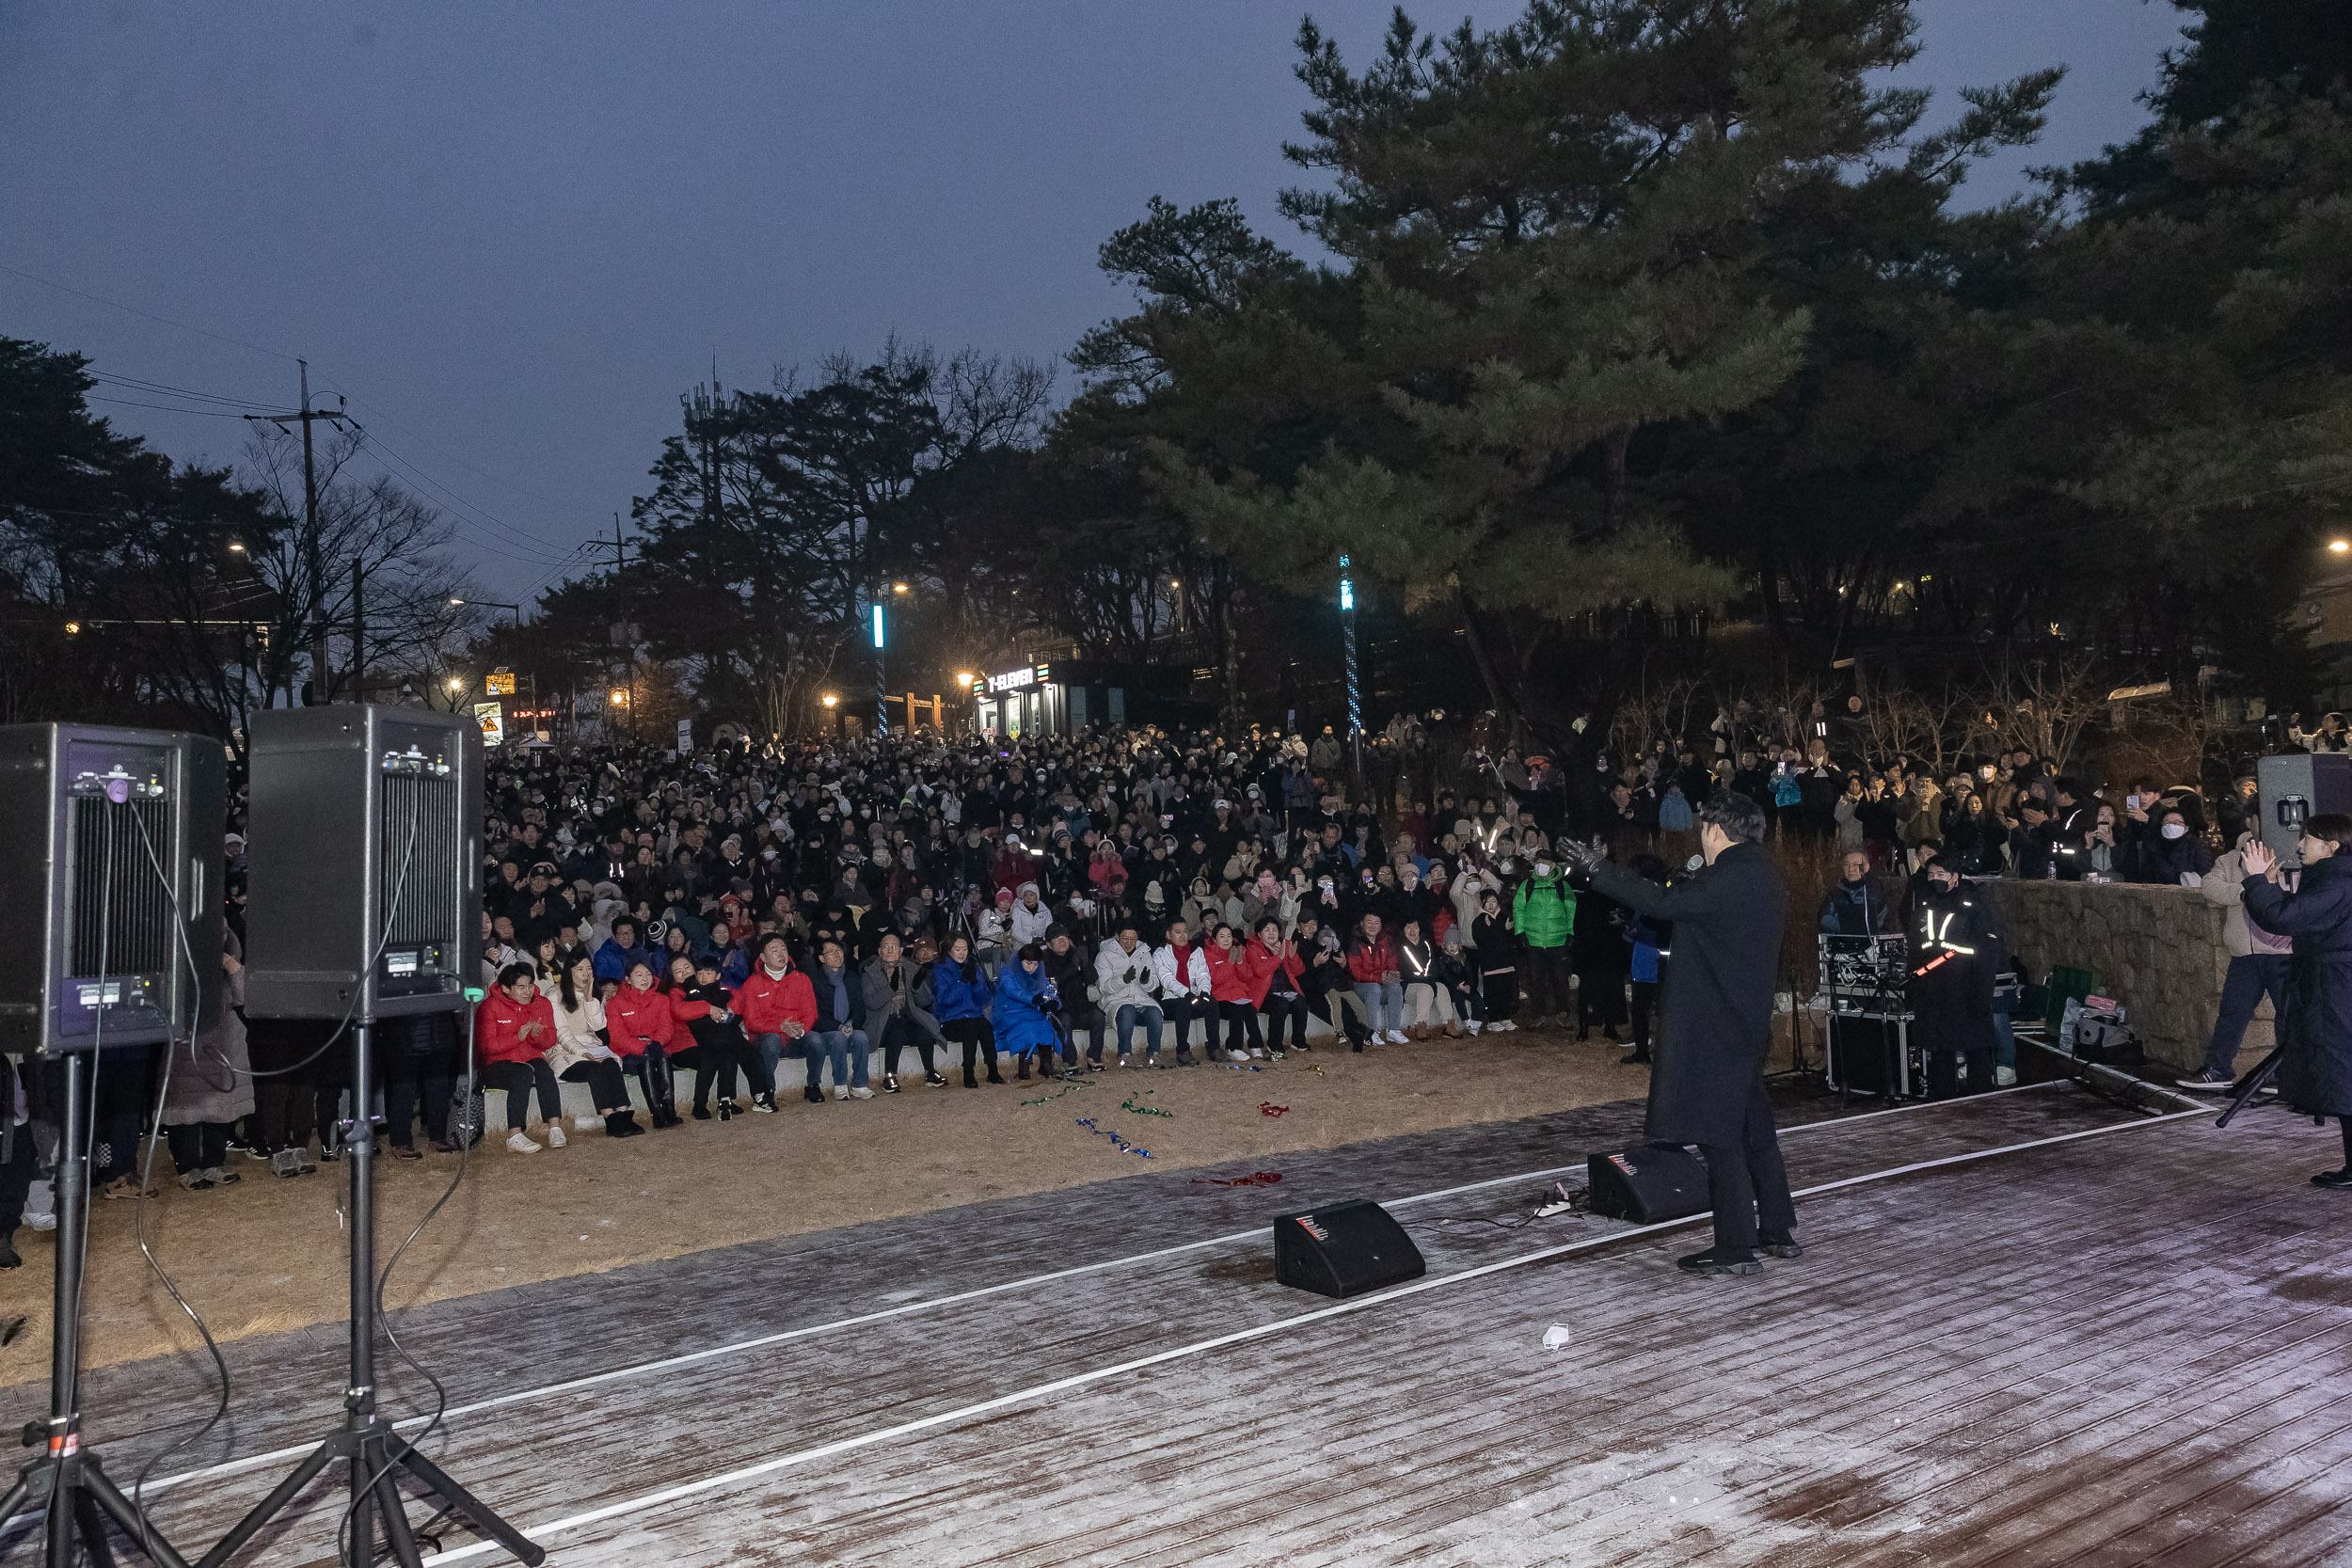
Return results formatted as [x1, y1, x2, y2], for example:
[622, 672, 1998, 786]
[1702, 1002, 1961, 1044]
[0, 724, 224, 1568]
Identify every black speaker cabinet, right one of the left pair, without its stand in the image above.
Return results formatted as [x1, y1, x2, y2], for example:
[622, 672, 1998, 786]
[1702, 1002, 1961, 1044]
[245, 705, 483, 1022]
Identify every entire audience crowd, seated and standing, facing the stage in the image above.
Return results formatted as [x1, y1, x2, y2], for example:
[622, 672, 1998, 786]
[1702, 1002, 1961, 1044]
[0, 701, 2327, 1262]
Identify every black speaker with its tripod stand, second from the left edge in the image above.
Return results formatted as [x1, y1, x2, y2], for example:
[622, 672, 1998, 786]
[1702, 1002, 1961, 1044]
[200, 707, 546, 1568]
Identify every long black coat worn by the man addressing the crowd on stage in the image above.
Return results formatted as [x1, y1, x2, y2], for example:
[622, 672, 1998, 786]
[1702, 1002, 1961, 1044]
[1593, 844, 1788, 1145]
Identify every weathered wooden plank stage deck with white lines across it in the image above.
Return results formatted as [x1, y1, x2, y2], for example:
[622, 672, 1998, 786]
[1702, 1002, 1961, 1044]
[0, 1086, 2352, 1568]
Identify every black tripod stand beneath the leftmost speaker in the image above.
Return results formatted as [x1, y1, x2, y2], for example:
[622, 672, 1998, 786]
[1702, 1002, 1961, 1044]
[0, 1053, 188, 1568]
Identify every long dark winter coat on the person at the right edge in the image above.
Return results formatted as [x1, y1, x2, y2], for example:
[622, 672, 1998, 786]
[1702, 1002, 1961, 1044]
[2247, 853, 2352, 1117]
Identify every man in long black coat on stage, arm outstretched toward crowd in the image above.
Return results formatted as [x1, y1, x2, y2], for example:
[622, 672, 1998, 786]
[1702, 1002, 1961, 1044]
[1562, 792, 1804, 1275]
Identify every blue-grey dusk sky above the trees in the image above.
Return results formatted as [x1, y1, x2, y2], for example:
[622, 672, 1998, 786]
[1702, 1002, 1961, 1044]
[0, 0, 2181, 599]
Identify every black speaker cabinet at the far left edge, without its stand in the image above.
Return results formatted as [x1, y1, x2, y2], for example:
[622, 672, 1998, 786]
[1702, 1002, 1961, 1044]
[0, 724, 226, 1055]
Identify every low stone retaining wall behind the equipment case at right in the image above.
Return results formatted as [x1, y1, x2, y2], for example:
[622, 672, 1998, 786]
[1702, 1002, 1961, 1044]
[1979, 879, 2270, 1069]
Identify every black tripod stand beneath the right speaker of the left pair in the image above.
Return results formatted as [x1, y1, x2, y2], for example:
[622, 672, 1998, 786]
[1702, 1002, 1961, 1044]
[198, 1022, 548, 1568]
